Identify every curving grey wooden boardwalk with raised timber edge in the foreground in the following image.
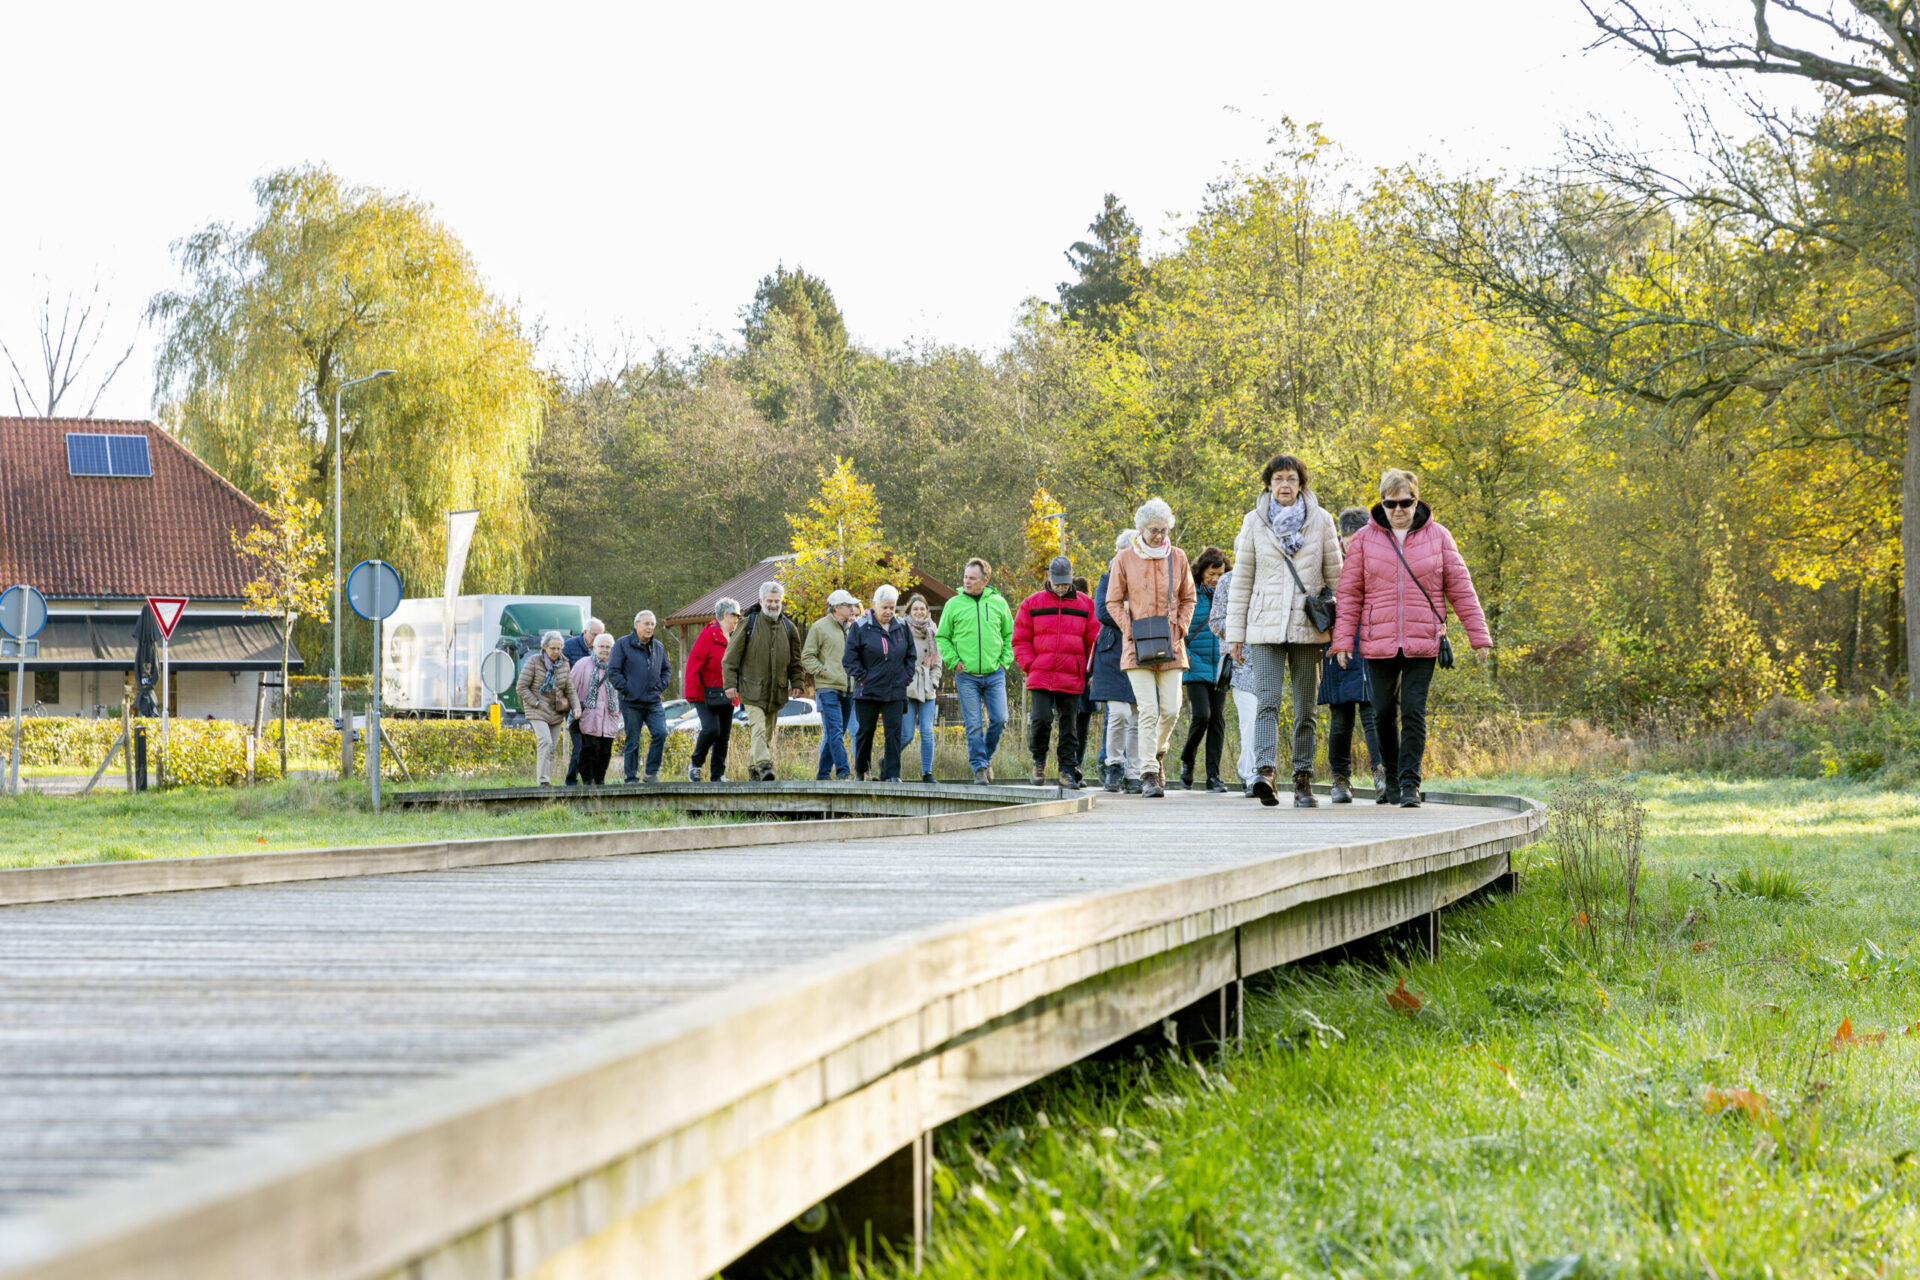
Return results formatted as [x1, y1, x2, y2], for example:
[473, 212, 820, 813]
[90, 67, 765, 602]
[0, 793, 1540, 1280]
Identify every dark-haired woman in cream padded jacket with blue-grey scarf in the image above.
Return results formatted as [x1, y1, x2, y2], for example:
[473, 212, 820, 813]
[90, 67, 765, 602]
[1227, 453, 1342, 808]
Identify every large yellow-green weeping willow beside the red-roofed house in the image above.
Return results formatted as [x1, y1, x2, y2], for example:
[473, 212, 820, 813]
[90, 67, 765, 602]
[148, 167, 545, 670]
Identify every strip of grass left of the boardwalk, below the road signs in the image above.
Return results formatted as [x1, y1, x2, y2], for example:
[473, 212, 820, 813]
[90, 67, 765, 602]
[0, 779, 726, 867]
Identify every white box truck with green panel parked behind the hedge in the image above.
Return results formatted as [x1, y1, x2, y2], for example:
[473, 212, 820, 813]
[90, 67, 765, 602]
[380, 595, 593, 716]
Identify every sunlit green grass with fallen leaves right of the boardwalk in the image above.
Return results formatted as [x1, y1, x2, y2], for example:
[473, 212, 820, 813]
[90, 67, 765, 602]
[910, 777, 1920, 1280]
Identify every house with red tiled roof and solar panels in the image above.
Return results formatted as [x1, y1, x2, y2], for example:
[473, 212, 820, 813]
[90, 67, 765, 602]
[0, 416, 301, 720]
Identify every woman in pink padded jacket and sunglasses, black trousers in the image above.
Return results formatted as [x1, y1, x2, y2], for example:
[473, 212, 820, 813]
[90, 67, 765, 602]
[1332, 468, 1494, 808]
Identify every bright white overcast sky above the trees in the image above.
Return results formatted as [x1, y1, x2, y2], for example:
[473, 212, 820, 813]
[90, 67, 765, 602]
[0, 0, 1797, 416]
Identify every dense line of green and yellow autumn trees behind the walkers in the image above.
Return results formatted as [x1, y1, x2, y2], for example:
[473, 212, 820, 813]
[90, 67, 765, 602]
[156, 87, 1912, 722]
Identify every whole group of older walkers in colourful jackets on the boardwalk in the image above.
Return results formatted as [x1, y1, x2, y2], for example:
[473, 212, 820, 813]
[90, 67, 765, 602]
[518, 453, 1492, 808]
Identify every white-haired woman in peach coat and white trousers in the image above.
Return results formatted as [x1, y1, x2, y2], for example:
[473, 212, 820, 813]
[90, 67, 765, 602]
[1106, 497, 1198, 796]
